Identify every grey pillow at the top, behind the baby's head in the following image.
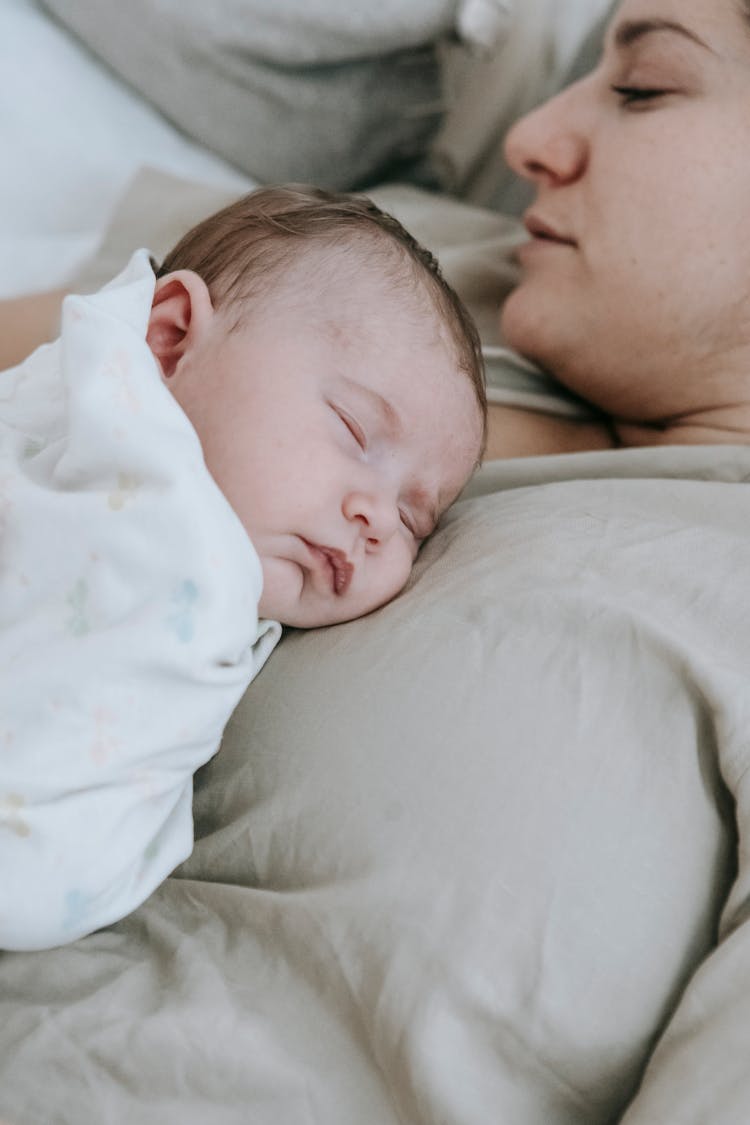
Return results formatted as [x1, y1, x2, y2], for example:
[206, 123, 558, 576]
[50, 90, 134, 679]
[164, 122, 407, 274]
[42, 0, 470, 189]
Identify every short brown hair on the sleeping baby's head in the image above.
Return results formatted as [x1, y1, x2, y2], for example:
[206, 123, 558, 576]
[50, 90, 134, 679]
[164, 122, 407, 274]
[156, 185, 487, 444]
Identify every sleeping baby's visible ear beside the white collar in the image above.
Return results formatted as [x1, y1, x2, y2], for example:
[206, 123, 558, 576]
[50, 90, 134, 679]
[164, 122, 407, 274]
[146, 270, 214, 379]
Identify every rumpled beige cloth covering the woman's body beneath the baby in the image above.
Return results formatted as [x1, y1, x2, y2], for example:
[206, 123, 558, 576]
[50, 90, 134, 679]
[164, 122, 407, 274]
[0, 180, 750, 1125]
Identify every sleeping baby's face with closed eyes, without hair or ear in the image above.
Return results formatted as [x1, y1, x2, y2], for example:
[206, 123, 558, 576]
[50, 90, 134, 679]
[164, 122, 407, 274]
[163, 268, 481, 628]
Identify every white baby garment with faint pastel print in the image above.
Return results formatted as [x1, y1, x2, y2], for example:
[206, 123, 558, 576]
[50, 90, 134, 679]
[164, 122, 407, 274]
[0, 251, 280, 950]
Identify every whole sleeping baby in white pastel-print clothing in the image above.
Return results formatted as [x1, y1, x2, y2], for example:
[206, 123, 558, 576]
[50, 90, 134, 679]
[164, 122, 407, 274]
[0, 188, 486, 950]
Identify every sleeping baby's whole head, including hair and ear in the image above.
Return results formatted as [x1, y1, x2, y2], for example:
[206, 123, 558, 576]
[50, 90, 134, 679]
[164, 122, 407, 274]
[147, 187, 487, 628]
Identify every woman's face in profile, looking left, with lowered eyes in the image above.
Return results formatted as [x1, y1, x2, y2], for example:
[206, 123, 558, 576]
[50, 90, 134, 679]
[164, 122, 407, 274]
[503, 0, 750, 421]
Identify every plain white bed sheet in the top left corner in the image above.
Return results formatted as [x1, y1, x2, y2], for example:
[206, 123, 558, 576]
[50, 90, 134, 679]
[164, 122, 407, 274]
[0, 0, 253, 298]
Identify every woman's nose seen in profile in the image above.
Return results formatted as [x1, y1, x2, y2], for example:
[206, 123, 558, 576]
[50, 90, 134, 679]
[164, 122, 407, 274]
[505, 83, 588, 186]
